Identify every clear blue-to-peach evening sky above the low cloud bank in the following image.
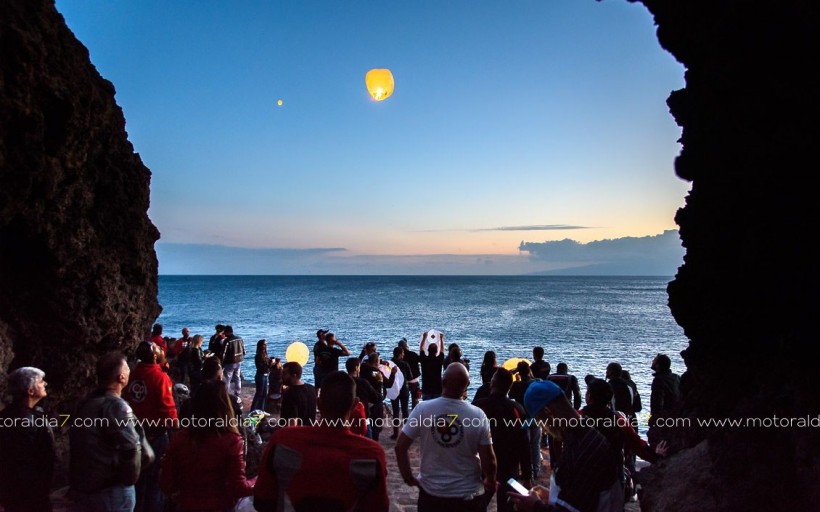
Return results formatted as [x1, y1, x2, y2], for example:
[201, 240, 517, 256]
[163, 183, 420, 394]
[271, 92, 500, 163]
[57, 0, 688, 273]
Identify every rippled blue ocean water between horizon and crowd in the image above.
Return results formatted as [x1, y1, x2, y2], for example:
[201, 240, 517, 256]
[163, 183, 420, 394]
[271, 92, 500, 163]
[158, 276, 687, 416]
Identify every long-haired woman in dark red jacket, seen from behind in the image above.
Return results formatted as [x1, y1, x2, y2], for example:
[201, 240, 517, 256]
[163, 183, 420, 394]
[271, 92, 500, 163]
[160, 380, 253, 512]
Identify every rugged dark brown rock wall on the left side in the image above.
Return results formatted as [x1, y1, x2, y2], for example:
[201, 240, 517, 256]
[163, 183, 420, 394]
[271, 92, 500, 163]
[0, 0, 160, 415]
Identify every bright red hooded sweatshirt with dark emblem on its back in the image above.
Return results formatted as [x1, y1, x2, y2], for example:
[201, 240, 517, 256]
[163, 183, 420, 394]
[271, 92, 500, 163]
[123, 363, 177, 428]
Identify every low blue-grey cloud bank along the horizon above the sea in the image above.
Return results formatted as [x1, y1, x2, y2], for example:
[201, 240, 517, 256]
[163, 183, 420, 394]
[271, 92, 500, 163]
[156, 230, 684, 276]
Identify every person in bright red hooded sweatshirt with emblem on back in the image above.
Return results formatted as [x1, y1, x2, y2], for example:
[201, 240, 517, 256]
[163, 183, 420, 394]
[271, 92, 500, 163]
[123, 341, 177, 512]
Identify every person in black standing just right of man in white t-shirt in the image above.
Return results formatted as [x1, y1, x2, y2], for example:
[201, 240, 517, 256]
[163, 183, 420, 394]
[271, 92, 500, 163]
[473, 368, 532, 512]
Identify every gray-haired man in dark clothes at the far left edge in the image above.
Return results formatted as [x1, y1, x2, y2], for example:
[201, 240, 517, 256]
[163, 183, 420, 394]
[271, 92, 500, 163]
[0, 366, 56, 512]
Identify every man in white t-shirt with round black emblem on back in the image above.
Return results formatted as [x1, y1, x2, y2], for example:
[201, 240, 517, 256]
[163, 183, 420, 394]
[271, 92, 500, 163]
[396, 363, 496, 512]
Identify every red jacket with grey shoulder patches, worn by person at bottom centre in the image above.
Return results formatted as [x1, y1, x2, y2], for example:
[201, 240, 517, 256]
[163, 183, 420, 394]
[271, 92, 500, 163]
[253, 426, 390, 512]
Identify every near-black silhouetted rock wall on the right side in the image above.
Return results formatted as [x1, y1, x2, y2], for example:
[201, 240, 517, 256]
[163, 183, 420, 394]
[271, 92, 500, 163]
[640, 0, 820, 510]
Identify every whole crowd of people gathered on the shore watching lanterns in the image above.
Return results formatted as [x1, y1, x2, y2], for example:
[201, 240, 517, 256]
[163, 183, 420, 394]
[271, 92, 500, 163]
[0, 324, 681, 512]
